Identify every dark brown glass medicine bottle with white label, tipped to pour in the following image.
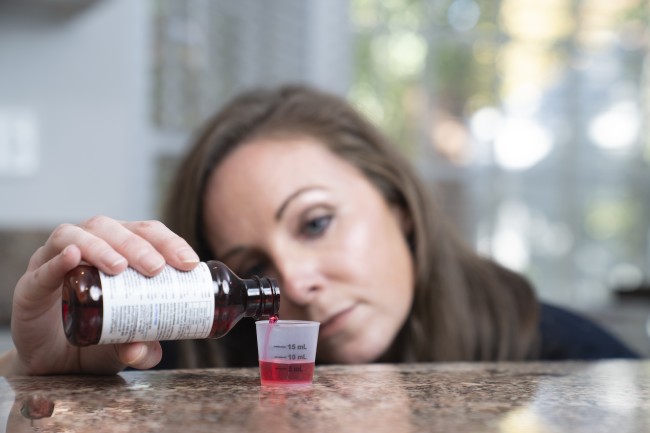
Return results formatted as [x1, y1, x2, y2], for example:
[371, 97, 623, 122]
[62, 261, 280, 346]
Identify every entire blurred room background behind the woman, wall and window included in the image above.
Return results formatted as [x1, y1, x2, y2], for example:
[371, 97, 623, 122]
[0, 0, 650, 355]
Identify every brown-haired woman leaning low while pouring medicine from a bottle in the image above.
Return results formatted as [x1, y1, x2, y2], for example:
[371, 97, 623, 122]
[0, 87, 634, 374]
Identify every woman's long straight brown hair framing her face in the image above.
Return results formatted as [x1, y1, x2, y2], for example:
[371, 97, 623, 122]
[164, 86, 539, 367]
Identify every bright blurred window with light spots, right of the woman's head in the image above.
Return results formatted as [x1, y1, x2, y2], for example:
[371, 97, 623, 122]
[350, 0, 650, 307]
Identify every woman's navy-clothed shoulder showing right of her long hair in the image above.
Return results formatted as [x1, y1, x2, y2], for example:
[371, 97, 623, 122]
[539, 303, 639, 360]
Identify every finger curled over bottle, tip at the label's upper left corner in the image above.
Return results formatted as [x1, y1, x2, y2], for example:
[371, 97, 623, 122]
[38, 223, 127, 274]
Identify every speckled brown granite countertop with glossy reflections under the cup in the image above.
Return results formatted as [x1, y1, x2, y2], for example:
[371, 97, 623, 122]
[0, 361, 650, 433]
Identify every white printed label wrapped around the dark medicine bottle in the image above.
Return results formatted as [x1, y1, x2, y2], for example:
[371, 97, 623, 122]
[99, 263, 214, 344]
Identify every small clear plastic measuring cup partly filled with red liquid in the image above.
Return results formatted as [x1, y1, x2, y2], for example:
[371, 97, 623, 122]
[255, 320, 320, 385]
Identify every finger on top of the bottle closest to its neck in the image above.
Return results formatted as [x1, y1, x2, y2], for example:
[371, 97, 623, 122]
[124, 221, 199, 270]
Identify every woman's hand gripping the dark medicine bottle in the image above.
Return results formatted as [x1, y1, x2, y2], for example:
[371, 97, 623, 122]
[0, 216, 199, 375]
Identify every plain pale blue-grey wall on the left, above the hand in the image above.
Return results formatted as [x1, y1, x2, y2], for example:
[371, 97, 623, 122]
[0, 0, 155, 323]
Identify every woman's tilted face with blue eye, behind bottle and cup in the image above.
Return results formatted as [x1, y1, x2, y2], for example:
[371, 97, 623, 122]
[204, 137, 414, 363]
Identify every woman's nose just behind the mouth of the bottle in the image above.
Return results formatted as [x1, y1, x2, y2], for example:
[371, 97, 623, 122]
[274, 249, 323, 313]
